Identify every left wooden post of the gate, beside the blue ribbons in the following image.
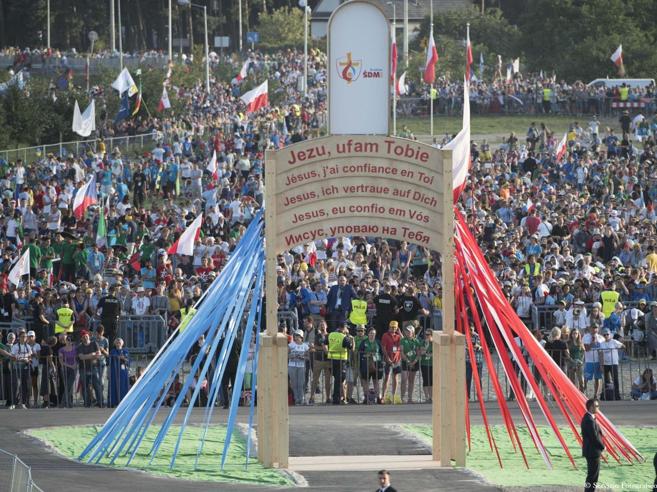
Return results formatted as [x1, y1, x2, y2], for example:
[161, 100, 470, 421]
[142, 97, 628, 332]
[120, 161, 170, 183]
[257, 151, 290, 468]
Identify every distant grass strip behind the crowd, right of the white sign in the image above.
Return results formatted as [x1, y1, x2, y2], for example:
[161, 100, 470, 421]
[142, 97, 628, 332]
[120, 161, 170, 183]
[397, 114, 619, 143]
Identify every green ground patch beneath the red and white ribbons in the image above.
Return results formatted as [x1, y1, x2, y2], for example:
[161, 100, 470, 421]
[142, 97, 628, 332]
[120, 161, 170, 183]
[403, 425, 657, 490]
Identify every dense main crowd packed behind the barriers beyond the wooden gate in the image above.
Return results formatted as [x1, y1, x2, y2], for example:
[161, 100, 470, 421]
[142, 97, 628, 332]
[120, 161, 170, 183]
[0, 45, 657, 408]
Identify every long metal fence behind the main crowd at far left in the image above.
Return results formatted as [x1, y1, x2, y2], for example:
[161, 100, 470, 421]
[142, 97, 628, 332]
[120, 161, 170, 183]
[0, 131, 158, 162]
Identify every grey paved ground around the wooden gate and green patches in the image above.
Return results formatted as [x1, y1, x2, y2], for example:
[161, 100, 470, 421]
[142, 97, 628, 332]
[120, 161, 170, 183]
[0, 402, 656, 492]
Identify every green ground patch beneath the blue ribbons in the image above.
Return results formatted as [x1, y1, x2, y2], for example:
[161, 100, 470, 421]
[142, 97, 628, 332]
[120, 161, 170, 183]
[28, 425, 294, 486]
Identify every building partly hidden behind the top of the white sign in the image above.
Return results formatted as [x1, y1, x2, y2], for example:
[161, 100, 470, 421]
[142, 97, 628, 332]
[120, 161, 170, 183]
[310, 0, 473, 39]
